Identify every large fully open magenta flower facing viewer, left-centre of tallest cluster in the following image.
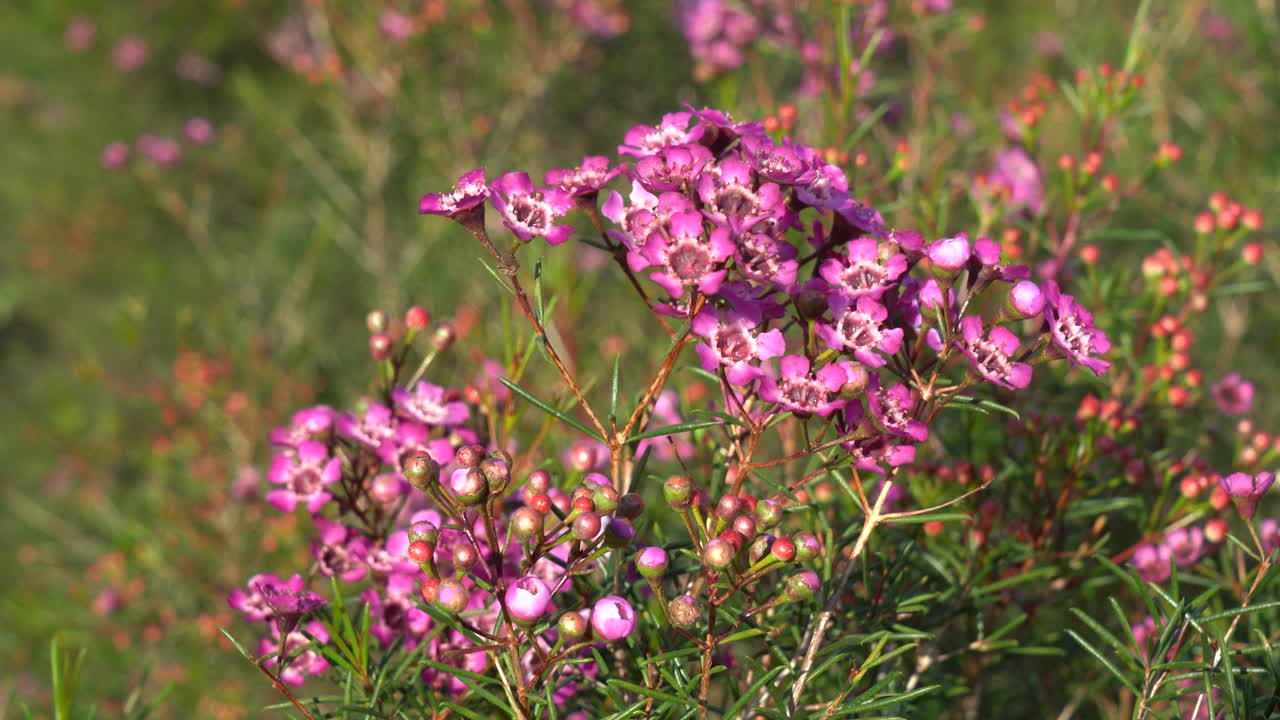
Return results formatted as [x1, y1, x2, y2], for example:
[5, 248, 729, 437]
[641, 213, 733, 297]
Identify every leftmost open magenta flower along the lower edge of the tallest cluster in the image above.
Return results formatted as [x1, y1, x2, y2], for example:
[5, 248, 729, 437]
[692, 306, 786, 386]
